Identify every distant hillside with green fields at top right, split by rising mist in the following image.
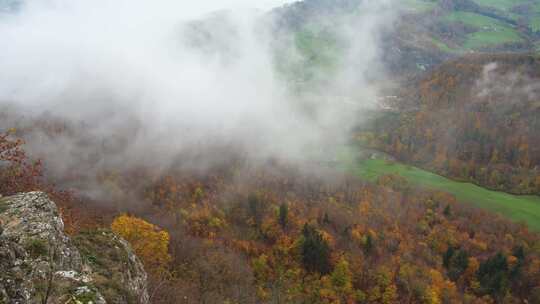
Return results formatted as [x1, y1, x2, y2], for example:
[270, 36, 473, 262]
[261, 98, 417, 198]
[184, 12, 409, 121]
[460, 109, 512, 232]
[273, 0, 540, 80]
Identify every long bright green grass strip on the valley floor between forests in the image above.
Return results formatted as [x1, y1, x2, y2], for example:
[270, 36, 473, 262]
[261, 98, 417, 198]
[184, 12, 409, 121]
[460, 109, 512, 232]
[338, 152, 540, 231]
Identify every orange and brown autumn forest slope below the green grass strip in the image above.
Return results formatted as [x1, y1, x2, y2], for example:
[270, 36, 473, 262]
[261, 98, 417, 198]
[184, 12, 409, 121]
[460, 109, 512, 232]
[0, 124, 540, 303]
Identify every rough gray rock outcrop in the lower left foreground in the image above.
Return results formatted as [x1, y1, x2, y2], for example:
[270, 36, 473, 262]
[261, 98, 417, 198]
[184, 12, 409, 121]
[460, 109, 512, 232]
[0, 192, 149, 304]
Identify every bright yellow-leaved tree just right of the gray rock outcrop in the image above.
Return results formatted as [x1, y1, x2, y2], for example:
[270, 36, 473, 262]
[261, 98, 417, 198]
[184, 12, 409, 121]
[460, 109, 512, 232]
[111, 215, 171, 273]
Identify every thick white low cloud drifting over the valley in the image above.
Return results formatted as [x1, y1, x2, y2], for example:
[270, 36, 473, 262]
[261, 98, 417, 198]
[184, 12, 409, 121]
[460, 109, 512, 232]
[0, 0, 392, 197]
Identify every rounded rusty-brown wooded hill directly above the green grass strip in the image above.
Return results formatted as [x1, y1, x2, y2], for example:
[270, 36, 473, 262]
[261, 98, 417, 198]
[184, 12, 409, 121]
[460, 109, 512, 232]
[364, 55, 540, 194]
